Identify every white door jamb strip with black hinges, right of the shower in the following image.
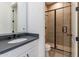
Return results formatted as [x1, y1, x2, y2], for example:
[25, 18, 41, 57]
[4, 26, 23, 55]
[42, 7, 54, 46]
[72, 2, 78, 57]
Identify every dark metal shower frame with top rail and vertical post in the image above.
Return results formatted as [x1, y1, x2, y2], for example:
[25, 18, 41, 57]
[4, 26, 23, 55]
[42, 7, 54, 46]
[46, 5, 71, 52]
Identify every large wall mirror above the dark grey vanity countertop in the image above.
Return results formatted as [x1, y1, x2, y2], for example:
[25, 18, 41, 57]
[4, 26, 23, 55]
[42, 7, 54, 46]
[0, 2, 27, 34]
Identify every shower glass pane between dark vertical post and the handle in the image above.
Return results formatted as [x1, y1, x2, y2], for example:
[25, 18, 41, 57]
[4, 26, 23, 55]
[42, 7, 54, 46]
[56, 9, 64, 50]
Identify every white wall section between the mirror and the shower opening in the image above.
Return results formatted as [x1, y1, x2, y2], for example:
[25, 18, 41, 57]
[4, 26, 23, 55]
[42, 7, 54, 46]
[28, 2, 45, 56]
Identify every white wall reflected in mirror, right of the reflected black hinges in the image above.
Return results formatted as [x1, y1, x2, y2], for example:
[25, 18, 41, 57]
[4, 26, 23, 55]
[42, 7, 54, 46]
[17, 2, 28, 32]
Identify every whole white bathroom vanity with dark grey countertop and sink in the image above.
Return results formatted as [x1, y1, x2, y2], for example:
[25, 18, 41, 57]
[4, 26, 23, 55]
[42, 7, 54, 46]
[0, 33, 39, 57]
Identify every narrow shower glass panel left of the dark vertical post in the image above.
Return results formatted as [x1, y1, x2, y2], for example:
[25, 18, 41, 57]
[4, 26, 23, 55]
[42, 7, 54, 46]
[45, 11, 54, 47]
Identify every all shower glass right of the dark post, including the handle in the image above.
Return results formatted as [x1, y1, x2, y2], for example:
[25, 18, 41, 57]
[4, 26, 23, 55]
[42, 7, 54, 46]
[56, 3, 72, 56]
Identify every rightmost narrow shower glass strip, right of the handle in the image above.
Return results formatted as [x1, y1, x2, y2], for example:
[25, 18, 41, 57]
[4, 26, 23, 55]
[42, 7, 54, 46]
[64, 6, 72, 56]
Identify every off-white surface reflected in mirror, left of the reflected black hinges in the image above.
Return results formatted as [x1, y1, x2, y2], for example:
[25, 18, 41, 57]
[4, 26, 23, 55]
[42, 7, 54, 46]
[0, 2, 12, 34]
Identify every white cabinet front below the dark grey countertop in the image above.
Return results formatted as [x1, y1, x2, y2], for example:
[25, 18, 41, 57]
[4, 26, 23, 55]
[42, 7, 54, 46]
[0, 40, 38, 57]
